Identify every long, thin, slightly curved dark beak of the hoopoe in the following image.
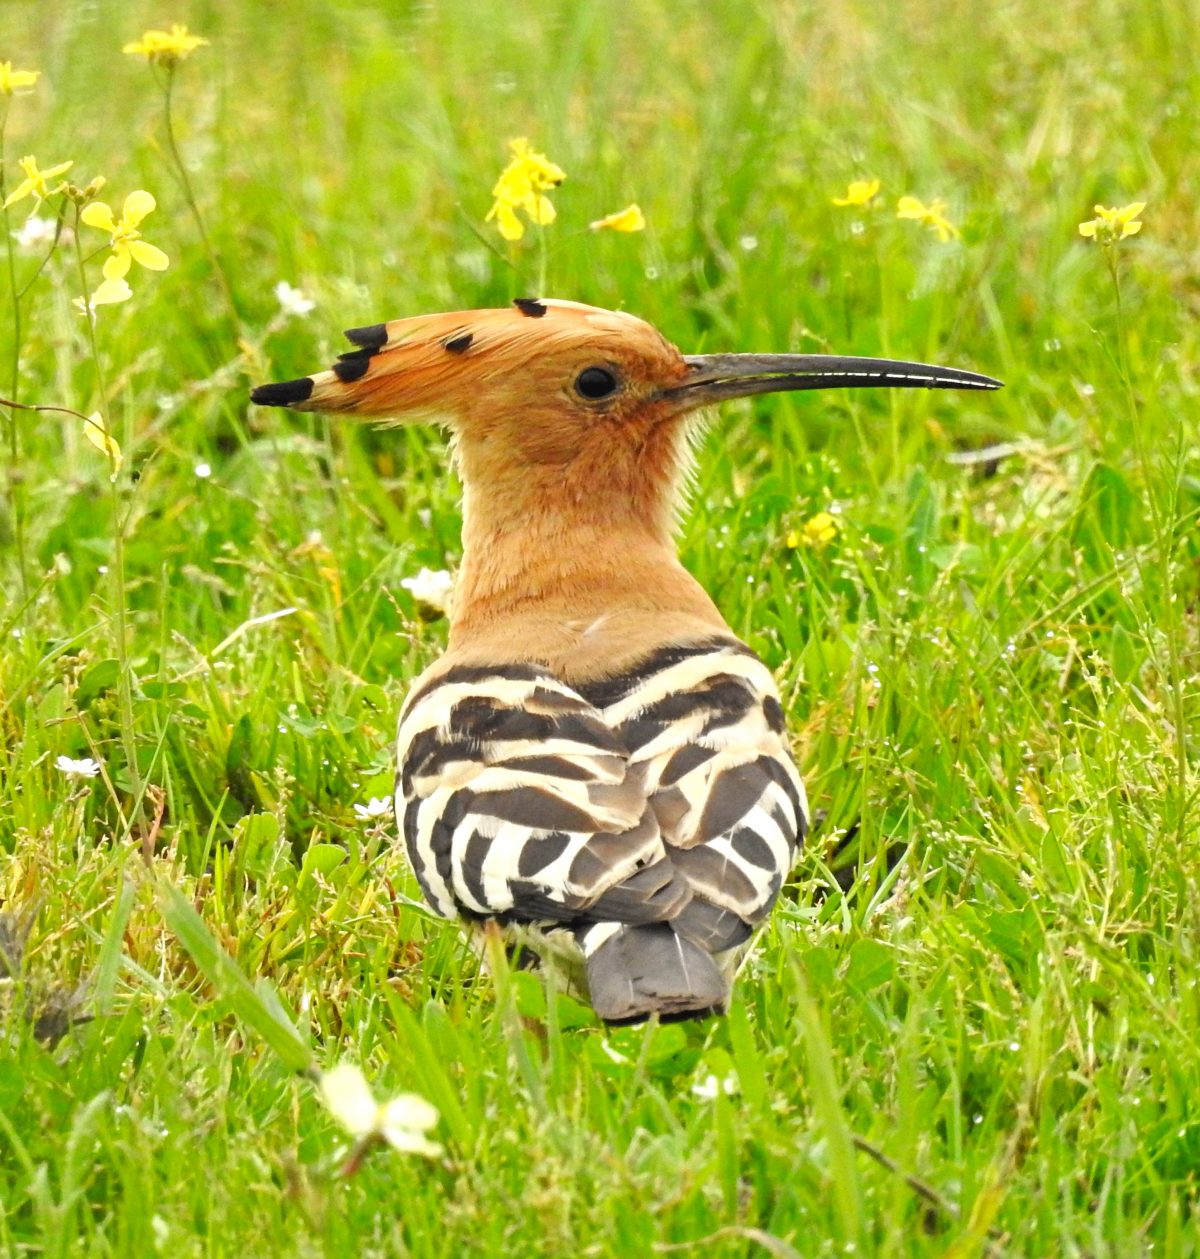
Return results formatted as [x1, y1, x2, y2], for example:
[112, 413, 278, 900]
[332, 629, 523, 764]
[664, 354, 1004, 409]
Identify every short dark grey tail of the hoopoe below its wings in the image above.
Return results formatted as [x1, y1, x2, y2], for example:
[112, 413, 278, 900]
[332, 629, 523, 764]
[580, 923, 729, 1024]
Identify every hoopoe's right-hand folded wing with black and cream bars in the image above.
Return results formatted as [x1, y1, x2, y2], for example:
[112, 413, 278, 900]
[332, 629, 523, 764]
[593, 641, 808, 953]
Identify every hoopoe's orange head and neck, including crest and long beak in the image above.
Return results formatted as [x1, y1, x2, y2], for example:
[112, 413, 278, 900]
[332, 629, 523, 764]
[251, 298, 999, 669]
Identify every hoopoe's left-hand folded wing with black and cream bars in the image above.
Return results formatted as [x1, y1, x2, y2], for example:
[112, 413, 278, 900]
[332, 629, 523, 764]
[397, 665, 690, 925]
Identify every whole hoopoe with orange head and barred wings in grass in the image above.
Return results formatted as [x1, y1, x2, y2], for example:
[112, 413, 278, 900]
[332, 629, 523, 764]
[251, 298, 1000, 1024]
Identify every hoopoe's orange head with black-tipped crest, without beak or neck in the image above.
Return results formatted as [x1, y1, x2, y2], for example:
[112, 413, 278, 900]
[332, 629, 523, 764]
[252, 300, 688, 533]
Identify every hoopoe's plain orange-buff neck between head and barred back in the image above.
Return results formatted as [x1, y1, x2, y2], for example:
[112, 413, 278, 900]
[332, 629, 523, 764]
[450, 420, 728, 677]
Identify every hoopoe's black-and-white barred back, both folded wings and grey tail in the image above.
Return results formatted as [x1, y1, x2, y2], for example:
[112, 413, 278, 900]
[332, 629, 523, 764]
[397, 632, 807, 1022]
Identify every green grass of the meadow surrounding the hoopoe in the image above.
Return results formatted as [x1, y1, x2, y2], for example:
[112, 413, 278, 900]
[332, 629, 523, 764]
[0, 0, 1200, 1256]
